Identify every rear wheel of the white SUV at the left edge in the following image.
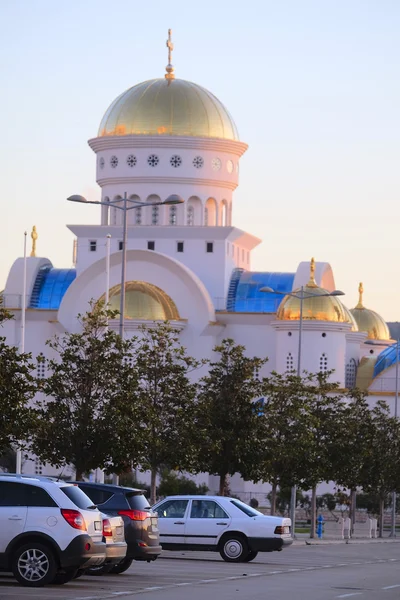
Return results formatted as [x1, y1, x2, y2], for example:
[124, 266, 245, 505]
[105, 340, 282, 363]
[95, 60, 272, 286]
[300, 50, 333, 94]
[11, 542, 57, 587]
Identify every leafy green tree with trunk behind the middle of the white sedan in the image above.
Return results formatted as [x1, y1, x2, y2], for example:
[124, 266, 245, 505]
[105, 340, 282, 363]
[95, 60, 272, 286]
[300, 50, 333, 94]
[197, 339, 267, 496]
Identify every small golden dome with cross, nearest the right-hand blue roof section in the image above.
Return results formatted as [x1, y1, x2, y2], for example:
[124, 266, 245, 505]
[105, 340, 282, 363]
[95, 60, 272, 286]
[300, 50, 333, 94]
[276, 258, 357, 331]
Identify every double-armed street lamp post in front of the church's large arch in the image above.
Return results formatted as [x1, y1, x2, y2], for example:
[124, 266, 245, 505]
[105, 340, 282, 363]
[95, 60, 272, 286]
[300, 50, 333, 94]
[67, 192, 184, 338]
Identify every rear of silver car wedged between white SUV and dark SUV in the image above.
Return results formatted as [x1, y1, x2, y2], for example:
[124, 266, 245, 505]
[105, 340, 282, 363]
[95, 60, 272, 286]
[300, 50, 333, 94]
[86, 513, 128, 575]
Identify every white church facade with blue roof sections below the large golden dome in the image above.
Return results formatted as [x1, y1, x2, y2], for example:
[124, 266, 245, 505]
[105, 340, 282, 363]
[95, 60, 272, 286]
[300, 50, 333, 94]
[0, 68, 394, 493]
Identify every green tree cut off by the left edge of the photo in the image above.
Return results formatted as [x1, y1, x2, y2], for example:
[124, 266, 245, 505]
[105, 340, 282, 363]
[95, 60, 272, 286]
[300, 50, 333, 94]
[0, 304, 37, 454]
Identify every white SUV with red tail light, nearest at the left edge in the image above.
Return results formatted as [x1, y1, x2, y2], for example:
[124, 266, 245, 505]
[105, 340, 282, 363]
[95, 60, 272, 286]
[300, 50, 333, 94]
[0, 474, 106, 587]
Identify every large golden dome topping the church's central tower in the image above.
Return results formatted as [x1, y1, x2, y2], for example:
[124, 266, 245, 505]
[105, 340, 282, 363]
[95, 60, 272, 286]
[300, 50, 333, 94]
[98, 77, 239, 140]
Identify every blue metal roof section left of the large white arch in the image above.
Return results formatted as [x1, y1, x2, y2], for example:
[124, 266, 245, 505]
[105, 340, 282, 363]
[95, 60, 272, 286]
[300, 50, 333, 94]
[29, 265, 76, 310]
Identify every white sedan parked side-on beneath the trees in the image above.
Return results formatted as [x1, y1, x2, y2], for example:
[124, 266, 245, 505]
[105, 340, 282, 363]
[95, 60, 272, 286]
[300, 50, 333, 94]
[153, 496, 293, 562]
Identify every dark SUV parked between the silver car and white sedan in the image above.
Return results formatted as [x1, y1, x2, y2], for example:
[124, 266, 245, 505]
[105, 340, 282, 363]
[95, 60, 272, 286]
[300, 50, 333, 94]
[73, 481, 161, 573]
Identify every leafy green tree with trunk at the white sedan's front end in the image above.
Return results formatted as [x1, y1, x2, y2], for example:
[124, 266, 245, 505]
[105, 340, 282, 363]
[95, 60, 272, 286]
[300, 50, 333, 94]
[126, 323, 203, 504]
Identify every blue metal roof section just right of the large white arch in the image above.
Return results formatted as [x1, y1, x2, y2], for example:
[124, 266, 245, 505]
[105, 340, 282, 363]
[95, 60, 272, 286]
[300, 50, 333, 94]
[226, 269, 295, 313]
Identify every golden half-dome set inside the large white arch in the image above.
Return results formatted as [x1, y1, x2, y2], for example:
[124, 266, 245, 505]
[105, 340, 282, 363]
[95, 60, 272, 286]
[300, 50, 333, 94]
[99, 281, 179, 321]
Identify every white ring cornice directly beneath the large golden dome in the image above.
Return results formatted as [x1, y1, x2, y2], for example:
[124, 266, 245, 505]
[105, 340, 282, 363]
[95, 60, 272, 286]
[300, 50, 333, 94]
[88, 135, 248, 156]
